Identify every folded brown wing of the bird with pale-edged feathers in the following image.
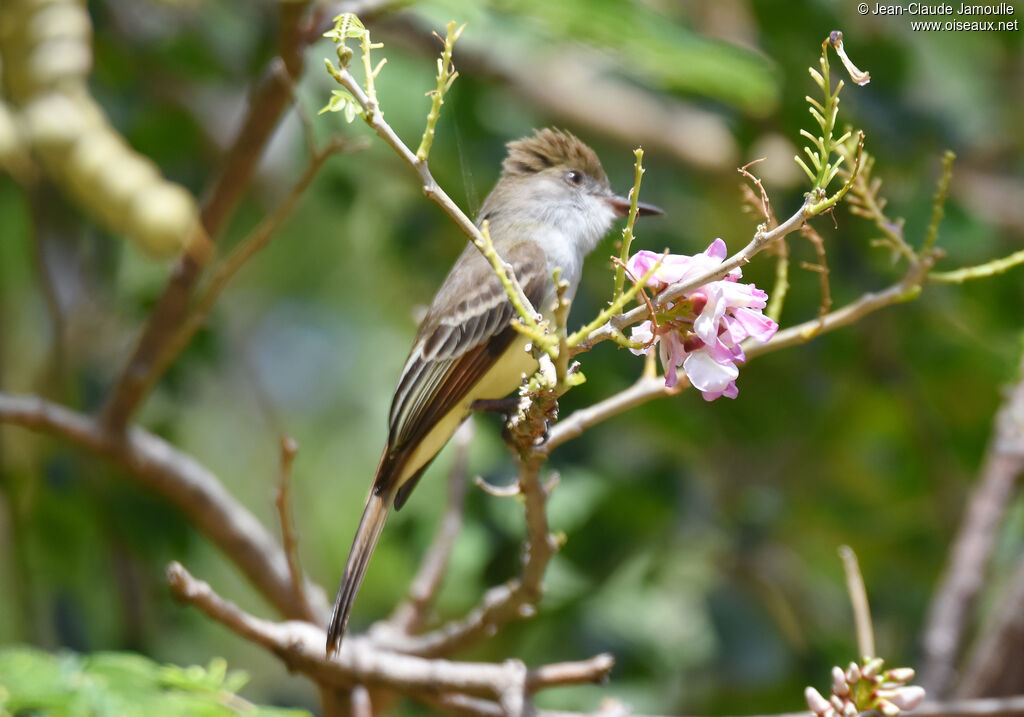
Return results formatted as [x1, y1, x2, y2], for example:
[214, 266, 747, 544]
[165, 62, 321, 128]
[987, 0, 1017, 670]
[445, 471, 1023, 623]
[375, 237, 548, 507]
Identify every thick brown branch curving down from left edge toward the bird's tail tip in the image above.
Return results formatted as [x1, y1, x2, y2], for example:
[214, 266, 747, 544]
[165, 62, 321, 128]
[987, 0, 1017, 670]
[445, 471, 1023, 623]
[0, 392, 328, 622]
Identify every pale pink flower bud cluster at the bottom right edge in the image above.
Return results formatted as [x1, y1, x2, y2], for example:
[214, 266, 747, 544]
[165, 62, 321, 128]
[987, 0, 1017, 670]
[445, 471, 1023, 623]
[804, 658, 925, 717]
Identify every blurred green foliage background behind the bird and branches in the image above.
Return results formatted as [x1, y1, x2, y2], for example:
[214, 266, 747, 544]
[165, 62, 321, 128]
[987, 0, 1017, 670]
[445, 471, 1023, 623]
[0, 0, 1024, 714]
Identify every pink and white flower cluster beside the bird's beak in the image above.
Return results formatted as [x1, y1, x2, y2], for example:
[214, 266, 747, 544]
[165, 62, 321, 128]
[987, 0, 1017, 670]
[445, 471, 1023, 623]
[627, 239, 778, 400]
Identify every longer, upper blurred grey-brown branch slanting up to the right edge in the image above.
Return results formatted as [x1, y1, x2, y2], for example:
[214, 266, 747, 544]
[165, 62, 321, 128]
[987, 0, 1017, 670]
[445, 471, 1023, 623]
[921, 350, 1024, 697]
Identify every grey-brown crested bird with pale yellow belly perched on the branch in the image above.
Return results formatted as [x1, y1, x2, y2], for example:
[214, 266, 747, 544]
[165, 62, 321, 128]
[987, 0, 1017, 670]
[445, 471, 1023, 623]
[327, 129, 662, 655]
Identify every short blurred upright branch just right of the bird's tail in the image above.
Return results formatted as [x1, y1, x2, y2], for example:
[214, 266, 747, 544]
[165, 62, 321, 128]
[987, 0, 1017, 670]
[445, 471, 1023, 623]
[388, 421, 473, 634]
